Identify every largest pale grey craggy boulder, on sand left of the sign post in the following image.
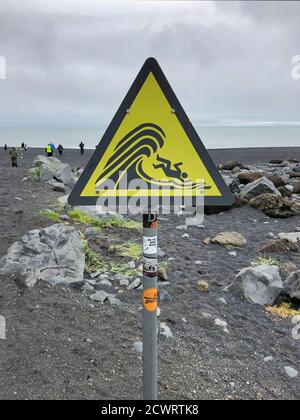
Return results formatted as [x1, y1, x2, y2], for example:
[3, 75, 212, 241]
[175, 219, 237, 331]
[0, 224, 85, 287]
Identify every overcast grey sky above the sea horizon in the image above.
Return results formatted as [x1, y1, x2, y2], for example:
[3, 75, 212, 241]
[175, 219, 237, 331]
[0, 0, 300, 127]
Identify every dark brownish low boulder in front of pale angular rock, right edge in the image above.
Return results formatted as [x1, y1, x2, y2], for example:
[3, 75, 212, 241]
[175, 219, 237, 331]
[250, 194, 299, 218]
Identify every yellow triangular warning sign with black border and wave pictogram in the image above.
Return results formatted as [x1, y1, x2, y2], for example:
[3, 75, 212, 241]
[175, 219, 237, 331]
[69, 58, 234, 206]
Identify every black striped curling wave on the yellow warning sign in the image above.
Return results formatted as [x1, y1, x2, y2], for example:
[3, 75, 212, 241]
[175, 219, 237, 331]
[96, 123, 166, 188]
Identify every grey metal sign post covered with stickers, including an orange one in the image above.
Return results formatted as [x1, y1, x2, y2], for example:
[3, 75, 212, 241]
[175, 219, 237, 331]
[143, 212, 158, 400]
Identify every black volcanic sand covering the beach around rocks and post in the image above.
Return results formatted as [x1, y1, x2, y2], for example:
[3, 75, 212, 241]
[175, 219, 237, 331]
[0, 149, 300, 400]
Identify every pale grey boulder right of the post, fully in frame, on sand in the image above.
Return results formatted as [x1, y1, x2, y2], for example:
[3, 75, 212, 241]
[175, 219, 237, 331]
[230, 265, 283, 305]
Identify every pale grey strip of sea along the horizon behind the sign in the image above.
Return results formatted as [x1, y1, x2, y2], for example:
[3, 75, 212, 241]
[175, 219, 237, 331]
[0, 124, 300, 149]
